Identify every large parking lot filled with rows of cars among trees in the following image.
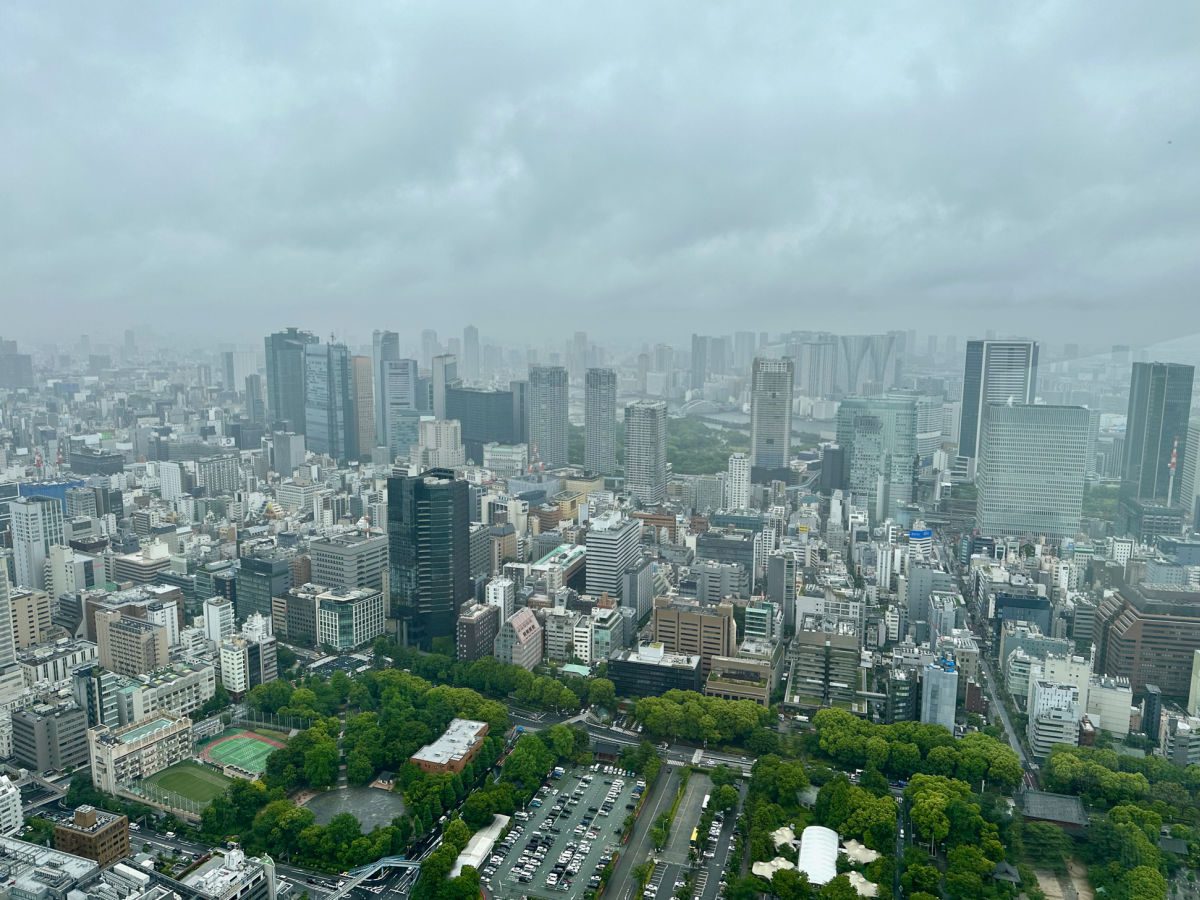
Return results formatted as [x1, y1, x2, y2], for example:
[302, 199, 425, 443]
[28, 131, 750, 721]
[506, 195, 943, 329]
[482, 763, 640, 899]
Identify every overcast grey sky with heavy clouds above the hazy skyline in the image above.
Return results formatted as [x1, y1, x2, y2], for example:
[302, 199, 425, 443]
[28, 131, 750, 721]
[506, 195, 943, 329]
[0, 0, 1200, 343]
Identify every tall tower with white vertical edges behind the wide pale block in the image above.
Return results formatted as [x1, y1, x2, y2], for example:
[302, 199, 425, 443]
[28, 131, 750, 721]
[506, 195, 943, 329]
[959, 341, 1038, 457]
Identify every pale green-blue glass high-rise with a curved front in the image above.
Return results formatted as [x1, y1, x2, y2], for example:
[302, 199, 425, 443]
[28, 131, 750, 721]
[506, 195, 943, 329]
[838, 397, 917, 523]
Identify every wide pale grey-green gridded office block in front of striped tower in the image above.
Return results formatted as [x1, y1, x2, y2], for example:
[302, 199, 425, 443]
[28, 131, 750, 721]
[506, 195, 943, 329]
[976, 403, 1090, 538]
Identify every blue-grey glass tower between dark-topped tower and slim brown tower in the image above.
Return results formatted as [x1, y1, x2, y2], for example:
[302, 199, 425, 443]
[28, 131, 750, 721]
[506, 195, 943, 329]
[305, 343, 359, 461]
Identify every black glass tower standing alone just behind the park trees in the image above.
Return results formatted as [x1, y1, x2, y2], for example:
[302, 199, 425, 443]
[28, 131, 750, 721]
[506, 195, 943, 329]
[388, 469, 472, 648]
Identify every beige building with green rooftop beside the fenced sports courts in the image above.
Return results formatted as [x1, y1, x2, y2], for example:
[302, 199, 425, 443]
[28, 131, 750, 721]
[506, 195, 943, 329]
[86, 715, 192, 793]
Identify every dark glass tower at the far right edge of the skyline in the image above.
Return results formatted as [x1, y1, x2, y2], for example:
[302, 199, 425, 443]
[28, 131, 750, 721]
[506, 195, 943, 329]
[1118, 362, 1195, 532]
